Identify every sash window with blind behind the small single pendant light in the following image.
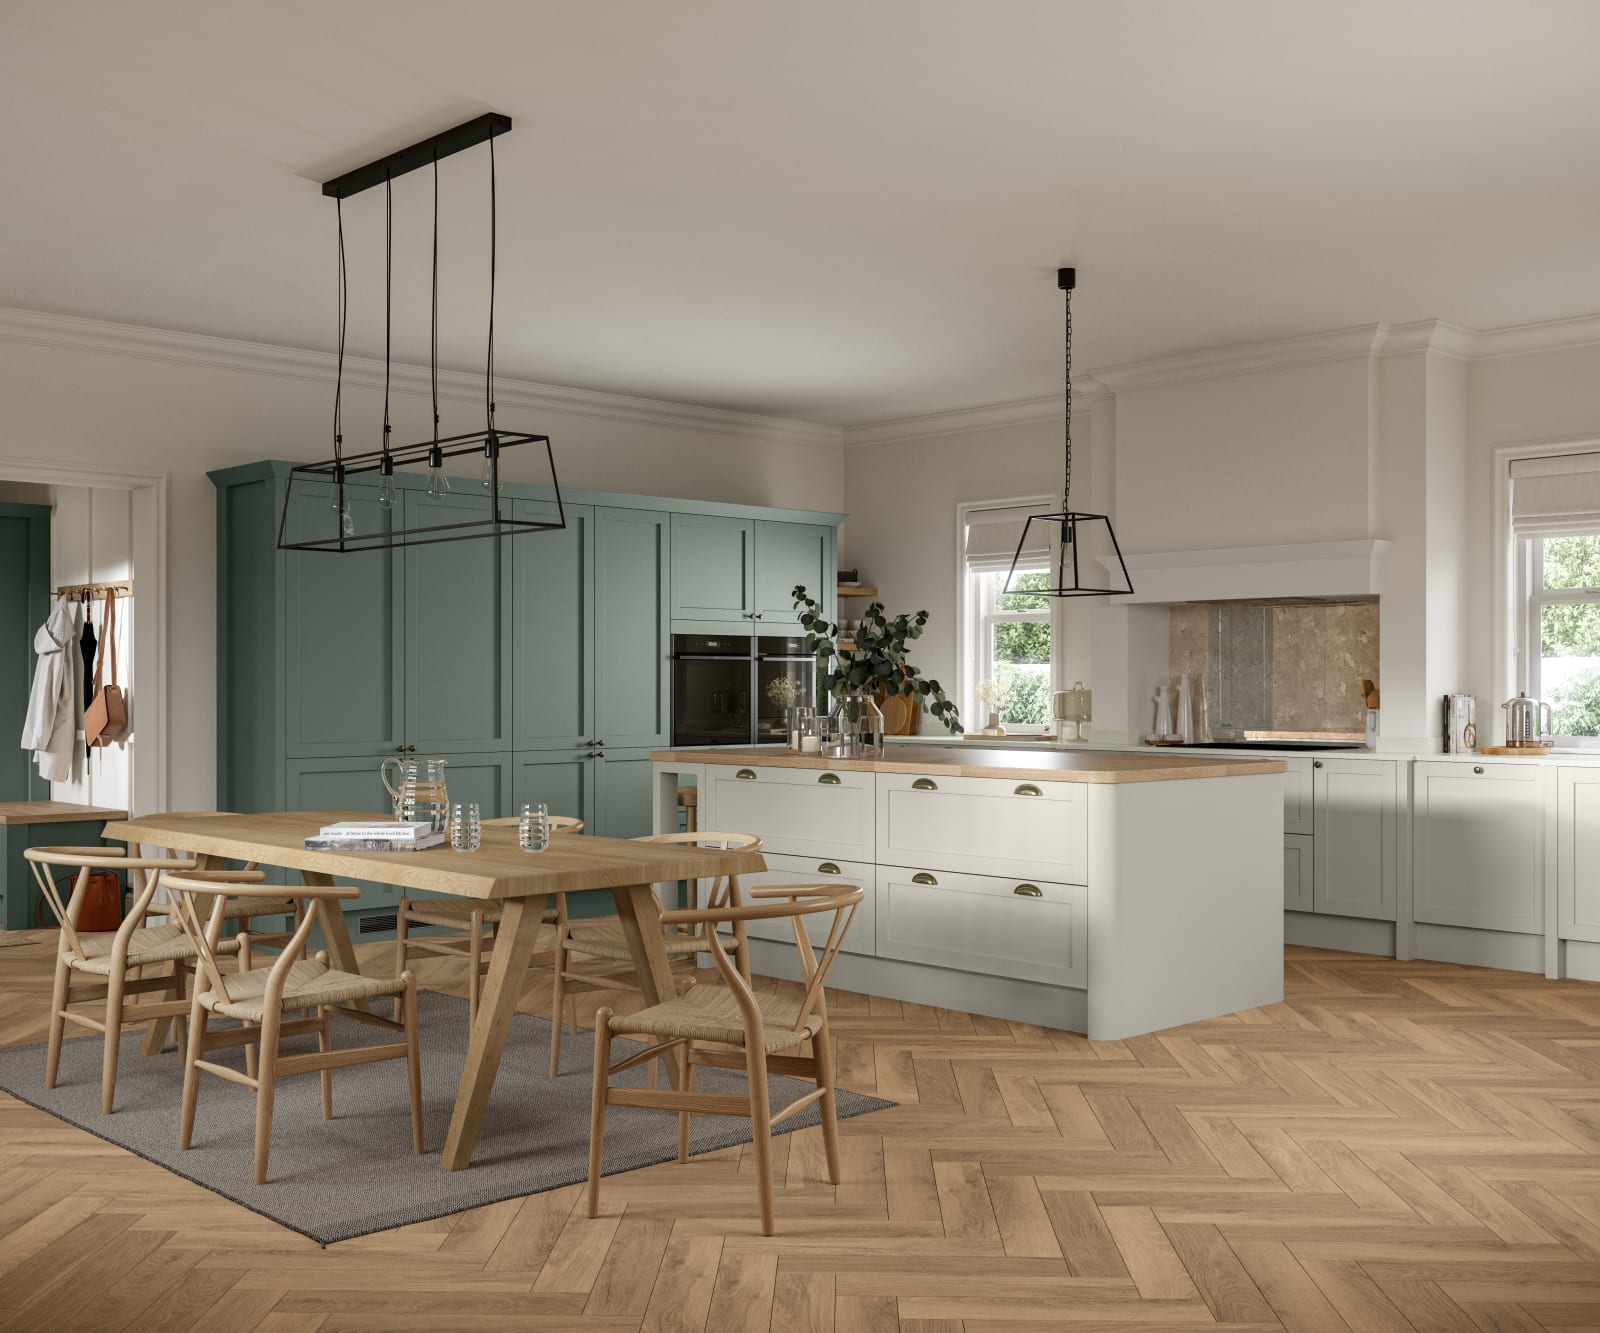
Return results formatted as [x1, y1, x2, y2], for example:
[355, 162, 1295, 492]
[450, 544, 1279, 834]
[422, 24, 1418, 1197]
[958, 498, 1056, 735]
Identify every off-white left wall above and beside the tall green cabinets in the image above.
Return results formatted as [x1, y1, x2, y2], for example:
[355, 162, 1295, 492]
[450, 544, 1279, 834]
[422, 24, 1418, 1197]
[0, 326, 843, 810]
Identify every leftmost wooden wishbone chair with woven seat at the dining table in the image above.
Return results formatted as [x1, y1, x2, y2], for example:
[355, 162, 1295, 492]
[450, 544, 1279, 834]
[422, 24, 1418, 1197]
[22, 847, 264, 1115]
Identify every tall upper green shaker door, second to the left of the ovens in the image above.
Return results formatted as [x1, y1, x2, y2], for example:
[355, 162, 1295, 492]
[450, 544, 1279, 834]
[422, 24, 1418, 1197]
[506, 499, 600, 751]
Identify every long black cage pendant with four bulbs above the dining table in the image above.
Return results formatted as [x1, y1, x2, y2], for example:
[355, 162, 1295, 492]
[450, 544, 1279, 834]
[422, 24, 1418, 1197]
[278, 114, 566, 552]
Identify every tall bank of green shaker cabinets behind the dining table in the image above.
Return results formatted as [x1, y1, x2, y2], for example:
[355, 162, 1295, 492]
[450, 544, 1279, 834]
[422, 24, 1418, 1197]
[211, 461, 843, 851]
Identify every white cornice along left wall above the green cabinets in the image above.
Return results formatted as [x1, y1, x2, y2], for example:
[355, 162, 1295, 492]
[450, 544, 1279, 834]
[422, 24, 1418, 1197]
[0, 307, 845, 446]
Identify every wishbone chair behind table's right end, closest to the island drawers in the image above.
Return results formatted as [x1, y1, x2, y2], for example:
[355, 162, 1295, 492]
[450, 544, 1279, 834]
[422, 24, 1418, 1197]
[546, 832, 762, 1079]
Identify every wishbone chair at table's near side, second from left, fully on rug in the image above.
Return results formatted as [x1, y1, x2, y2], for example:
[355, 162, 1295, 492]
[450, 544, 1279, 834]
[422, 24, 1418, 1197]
[162, 871, 422, 1184]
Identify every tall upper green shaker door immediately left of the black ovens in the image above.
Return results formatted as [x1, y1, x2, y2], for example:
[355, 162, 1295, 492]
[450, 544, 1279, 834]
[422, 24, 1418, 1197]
[601, 509, 674, 742]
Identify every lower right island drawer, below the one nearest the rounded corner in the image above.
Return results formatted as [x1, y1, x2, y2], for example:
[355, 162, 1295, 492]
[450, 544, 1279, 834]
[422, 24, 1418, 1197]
[877, 866, 1088, 986]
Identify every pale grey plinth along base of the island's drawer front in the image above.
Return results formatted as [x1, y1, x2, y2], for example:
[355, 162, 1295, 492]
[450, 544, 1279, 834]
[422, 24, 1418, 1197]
[736, 939, 1088, 1032]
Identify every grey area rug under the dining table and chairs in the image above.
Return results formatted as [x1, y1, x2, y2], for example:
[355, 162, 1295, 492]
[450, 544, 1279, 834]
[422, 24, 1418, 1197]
[0, 991, 894, 1245]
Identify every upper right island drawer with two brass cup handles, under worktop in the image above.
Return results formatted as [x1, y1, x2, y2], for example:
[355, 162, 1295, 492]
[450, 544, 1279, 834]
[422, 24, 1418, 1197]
[877, 773, 1088, 883]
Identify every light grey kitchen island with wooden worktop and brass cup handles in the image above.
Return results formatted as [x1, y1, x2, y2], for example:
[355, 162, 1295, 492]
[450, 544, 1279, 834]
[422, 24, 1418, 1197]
[651, 744, 1286, 1040]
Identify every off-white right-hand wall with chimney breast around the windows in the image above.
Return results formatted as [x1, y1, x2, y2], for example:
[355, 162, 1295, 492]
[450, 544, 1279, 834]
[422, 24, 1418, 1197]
[843, 325, 1600, 749]
